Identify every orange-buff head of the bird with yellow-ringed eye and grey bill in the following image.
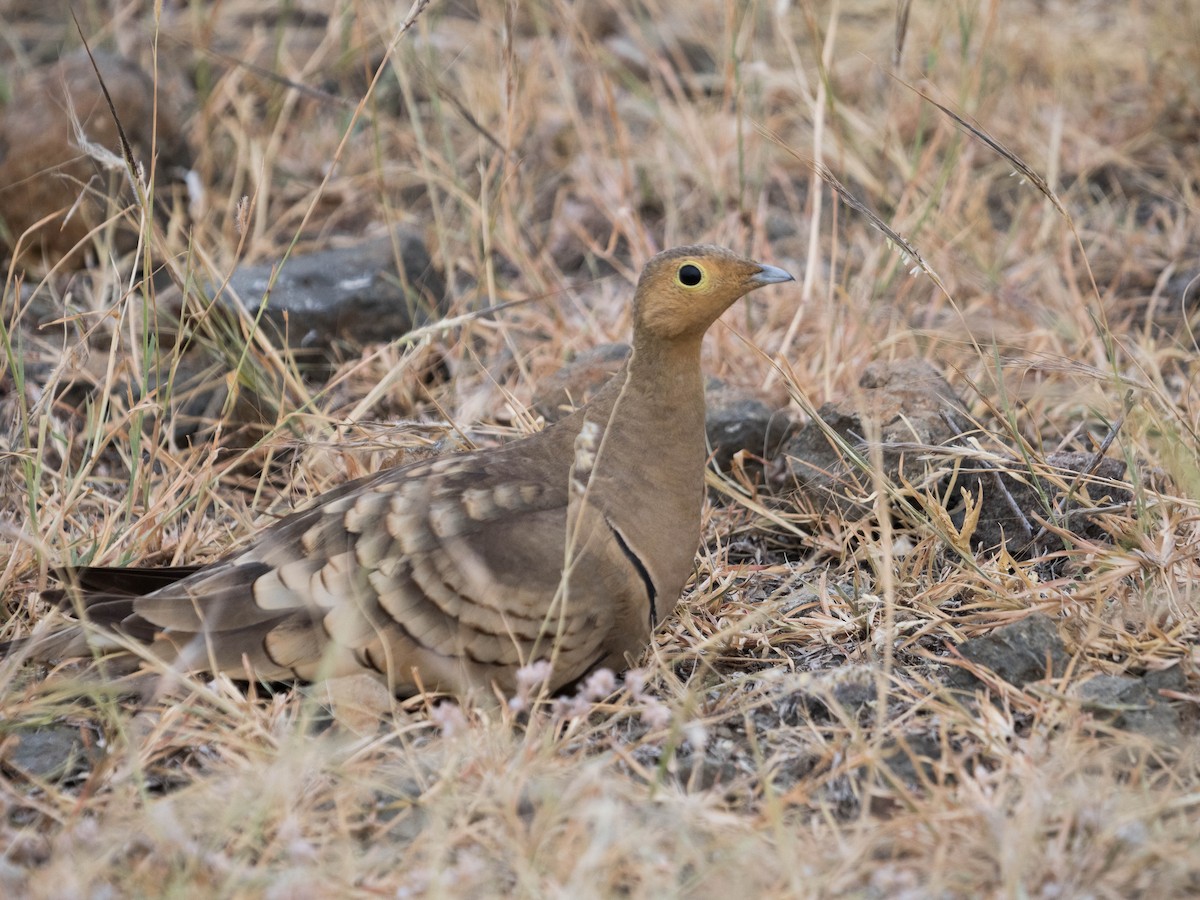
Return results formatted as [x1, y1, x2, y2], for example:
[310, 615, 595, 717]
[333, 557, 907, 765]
[634, 244, 794, 343]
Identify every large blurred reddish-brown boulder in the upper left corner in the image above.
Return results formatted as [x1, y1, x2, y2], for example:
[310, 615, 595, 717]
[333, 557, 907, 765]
[0, 52, 191, 266]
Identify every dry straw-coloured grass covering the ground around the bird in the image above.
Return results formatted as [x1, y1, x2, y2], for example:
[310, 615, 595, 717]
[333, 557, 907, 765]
[0, 0, 1200, 898]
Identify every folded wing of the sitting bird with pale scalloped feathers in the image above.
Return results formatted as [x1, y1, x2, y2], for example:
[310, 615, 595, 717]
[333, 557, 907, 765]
[111, 442, 644, 692]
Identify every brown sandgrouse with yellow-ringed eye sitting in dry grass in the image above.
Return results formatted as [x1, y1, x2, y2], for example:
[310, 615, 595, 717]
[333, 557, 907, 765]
[14, 245, 794, 697]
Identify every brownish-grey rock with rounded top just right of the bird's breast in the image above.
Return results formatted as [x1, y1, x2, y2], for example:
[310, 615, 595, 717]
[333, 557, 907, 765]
[772, 359, 967, 518]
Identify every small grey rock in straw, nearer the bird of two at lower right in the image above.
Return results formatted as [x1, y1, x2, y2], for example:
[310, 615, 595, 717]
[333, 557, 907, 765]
[949, 612, 1070, 690]
